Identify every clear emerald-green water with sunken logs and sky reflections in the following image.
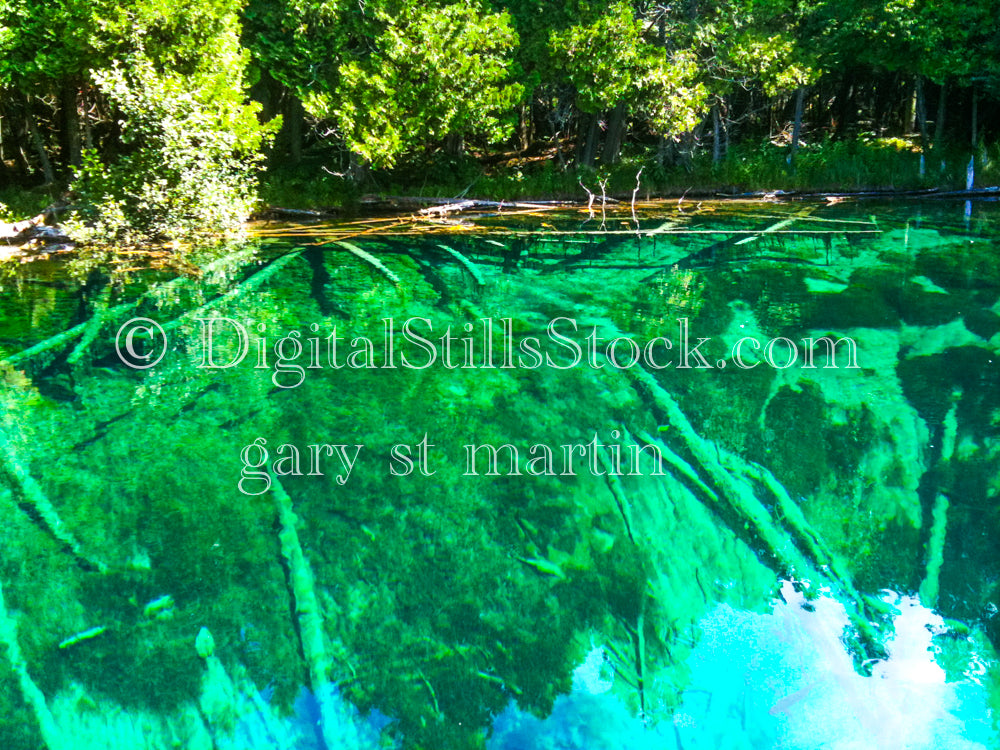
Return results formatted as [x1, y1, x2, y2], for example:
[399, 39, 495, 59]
[0, 202, 1000, 750]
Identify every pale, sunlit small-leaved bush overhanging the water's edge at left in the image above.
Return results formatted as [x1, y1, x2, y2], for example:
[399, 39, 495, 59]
[72, 14, 273, 244]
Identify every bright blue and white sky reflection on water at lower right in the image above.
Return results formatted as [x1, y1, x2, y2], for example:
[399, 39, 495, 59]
[487, 581, 995, 750]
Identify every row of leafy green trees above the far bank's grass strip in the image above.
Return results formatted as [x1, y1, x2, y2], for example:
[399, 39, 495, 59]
[0, 0, 1000, 217]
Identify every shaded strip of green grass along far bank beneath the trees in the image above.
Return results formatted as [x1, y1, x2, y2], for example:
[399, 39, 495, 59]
[262, 135, 1000, 208]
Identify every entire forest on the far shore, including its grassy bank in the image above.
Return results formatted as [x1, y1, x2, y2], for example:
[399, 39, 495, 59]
[0, 0, 1000, 244]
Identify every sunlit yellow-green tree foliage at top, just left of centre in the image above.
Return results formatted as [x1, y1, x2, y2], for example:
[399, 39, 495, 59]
[305, 4, 522, 166]
